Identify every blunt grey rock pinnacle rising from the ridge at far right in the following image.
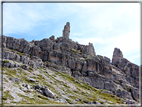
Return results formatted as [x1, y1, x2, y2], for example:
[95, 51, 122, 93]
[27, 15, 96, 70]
[112, 48, 123, 65]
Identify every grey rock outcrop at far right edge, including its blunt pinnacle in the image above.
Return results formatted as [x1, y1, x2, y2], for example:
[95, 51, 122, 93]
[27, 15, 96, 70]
[112, 48, 139, 88]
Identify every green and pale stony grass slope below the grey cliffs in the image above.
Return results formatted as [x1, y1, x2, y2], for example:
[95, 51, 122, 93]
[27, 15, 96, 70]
[3, 68, 122, 104]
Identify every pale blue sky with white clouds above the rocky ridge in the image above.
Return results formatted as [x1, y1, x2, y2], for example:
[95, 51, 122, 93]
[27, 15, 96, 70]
[3, 3, 140, 65]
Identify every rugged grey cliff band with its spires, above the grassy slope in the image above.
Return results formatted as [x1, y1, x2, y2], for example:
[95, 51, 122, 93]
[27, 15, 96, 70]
[2, 23, 139, 103]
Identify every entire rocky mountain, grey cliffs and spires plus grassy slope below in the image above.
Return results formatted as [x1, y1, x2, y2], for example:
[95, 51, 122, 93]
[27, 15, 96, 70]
[1, 22, 140, 105]
